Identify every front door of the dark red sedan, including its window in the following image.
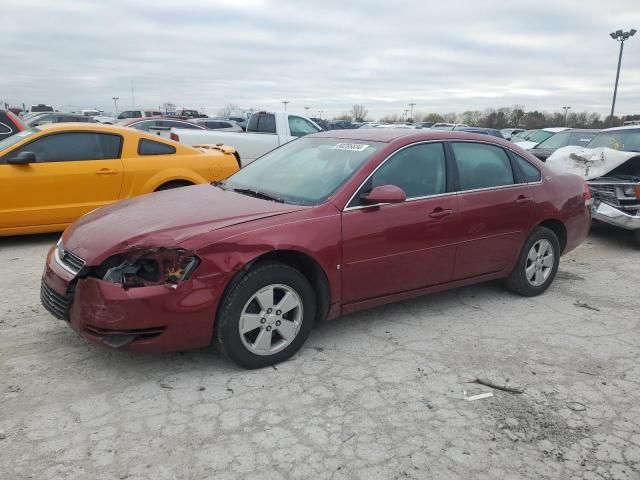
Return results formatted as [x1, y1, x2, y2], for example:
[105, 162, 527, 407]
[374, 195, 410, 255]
[342, 143, 458, 303]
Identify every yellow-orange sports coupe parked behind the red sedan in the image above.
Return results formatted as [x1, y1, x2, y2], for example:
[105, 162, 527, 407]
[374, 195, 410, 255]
[0, 123, 239, 236]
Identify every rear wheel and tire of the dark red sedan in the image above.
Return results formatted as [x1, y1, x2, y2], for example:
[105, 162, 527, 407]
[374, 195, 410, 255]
[505, 227, 560, 297]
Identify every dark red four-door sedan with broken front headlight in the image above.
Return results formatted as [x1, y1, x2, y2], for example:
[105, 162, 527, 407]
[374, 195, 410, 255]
[41, 129, 591, 368]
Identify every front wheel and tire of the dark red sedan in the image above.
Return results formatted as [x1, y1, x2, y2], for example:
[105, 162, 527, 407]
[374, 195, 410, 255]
[216, 262, 316, 368]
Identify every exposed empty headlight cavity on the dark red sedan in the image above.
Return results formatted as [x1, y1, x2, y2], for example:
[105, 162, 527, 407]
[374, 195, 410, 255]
[96, 248, 200, 289]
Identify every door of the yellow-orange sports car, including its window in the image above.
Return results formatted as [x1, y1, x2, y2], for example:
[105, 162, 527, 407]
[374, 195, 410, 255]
[0, 132, 122, 227]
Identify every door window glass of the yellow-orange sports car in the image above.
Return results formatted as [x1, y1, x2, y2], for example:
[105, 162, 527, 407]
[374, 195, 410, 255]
[3, 132, 122, 163]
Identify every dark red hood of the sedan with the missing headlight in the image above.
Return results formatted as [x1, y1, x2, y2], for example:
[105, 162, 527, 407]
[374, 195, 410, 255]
[62, 184, 307, 265]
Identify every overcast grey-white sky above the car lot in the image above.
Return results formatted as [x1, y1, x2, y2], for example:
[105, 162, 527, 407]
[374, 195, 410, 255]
[0, 0, 640, 118]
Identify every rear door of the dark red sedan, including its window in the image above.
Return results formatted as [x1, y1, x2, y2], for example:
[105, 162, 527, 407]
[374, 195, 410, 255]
[451, 142, 534, 280]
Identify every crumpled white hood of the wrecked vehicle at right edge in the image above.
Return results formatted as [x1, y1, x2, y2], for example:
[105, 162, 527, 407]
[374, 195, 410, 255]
[546, 146, 640, 180]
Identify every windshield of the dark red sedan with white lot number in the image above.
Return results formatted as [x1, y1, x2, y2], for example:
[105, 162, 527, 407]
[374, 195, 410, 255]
[221, 138, 384, 205]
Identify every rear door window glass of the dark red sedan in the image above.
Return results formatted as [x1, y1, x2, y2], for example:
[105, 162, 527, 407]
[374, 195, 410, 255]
[451, 142, 514, 190]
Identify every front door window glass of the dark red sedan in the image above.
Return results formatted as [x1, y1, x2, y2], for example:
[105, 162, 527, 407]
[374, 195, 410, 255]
[349, 143, 447, 207]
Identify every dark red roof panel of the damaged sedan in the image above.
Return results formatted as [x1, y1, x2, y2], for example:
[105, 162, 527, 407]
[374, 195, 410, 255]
[305, 128, 513, 148]
